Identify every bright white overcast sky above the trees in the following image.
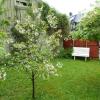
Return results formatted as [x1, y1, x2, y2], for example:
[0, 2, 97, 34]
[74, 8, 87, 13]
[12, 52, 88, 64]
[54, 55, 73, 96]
[43, 0, 95, 15]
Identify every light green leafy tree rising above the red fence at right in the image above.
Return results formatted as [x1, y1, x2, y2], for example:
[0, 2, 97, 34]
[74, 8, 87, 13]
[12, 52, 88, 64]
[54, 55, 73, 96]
[72, 1, 100, 41]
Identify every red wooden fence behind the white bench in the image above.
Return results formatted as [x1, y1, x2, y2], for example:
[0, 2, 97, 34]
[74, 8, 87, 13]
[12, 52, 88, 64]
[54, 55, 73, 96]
[63, 40, 99, 58]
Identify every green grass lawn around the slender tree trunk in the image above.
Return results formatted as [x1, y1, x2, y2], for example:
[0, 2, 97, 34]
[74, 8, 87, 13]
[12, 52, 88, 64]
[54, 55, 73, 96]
[0, 59, 100, 100]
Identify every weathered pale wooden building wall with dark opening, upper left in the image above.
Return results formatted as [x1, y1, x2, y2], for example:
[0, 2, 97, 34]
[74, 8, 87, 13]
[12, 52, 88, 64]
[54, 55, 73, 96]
[0, 0, 34, 21]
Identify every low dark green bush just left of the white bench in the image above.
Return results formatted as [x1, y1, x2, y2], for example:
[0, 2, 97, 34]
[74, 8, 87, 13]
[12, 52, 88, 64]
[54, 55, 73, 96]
[58, 48, 72, 59]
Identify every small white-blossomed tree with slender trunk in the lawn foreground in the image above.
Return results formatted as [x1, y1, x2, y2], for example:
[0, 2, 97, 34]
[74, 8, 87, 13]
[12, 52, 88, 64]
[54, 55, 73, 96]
[10, 4, 61, 98]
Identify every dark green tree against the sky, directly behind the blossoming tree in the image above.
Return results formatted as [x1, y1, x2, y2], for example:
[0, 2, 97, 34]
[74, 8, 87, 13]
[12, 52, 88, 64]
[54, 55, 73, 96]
[41, 2, 70, 41]
